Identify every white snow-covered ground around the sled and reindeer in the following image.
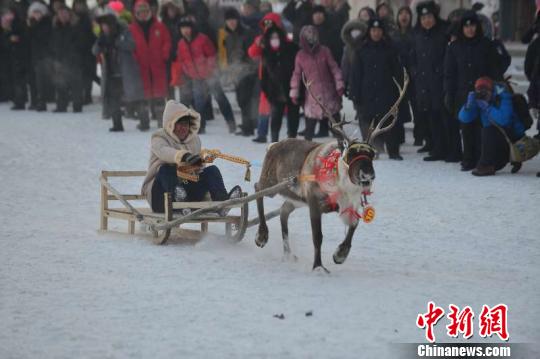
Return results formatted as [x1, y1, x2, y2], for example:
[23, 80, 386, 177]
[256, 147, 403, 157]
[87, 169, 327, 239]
[0, 99, 540, 359]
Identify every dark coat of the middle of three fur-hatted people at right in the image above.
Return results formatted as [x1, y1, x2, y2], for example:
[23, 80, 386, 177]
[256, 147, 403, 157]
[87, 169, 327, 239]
[409, 22, 448, 111]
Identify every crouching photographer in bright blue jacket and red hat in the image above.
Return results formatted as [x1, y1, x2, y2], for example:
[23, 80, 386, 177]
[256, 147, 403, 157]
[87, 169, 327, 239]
[458, 77, 540, 176]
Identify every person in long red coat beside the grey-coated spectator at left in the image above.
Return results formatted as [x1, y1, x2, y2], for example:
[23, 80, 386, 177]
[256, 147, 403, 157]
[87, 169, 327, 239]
[129, 0, 171, 127]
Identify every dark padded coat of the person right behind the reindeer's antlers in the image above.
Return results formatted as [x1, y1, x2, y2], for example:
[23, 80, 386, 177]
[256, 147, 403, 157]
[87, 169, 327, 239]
[350, 38, 403, 121]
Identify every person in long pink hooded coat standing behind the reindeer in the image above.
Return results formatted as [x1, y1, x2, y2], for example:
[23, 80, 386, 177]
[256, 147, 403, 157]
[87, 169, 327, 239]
[290, 25, 345, 141]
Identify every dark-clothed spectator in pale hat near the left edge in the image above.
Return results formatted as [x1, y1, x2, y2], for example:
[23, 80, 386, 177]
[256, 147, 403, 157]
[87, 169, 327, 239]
[28, 1, 52, 112]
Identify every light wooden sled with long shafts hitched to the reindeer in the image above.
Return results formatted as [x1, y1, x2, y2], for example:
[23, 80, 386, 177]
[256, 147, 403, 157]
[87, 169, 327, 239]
[100, 171, 296, 244]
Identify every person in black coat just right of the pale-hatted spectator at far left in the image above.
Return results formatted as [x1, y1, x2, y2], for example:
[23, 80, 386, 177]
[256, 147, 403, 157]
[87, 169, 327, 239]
[51, 5, 85, 112]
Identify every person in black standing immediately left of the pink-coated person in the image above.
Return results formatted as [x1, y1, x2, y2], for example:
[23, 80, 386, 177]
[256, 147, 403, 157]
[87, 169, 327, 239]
[261, 26, 299, 142]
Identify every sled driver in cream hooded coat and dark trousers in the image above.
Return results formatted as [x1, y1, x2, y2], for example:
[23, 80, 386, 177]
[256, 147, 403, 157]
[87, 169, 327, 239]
[142, 100, 242, 215]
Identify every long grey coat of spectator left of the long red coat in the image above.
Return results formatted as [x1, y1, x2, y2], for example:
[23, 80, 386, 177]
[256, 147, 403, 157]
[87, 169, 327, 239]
[92, 24, 145, 102]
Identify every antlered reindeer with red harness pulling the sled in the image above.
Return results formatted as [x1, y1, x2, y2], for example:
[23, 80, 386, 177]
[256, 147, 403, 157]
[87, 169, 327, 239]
[255, 69, 409, 273]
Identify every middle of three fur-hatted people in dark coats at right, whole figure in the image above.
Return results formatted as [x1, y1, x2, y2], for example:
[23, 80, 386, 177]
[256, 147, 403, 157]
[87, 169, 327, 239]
[411, 1, 448, 161]
